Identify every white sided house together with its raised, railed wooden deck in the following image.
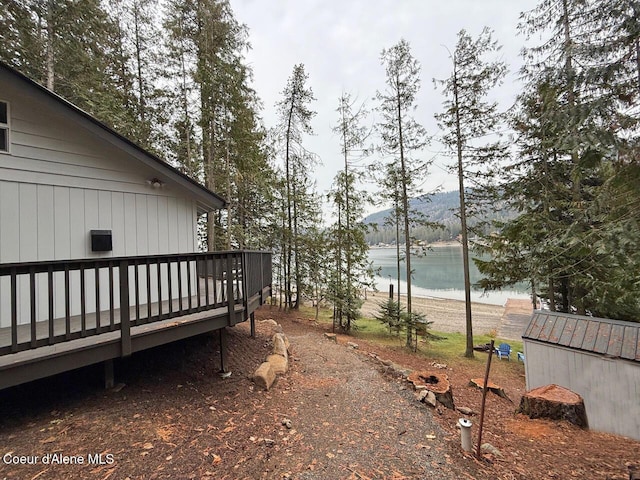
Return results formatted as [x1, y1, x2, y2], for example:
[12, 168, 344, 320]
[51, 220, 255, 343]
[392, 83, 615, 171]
[0, 63, 271, 388]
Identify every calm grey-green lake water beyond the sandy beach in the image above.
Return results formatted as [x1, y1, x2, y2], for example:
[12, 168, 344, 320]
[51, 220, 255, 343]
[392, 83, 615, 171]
[369, 245, 530, 305]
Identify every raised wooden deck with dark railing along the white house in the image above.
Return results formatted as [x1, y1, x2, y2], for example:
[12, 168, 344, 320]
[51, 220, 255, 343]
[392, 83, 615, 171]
[0, 252, 271, 389]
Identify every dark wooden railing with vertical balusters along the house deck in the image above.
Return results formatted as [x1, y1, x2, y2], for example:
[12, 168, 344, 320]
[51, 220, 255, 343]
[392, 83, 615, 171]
[0, 251, 271, 355]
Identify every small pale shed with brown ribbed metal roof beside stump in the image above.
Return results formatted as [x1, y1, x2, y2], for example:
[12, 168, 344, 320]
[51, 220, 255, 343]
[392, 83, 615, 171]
[522, 311, 640, 440]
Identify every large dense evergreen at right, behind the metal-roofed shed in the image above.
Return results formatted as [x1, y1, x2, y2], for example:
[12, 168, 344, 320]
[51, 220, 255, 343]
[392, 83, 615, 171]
[479, 0, 640, 319]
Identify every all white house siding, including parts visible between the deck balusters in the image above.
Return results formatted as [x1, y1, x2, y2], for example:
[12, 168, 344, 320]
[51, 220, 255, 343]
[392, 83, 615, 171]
[0, 71, 198, 327]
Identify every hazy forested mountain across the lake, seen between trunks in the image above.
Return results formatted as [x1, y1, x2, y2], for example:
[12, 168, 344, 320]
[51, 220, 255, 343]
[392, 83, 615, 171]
[363, 190, 514, 245]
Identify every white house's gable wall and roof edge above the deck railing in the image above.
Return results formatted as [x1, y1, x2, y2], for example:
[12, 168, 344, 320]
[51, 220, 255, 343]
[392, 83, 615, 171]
[0, 64, 225, 263]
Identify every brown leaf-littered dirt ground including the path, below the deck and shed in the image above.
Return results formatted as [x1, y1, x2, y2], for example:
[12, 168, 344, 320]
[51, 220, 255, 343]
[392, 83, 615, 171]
[0, 307, 640, 480]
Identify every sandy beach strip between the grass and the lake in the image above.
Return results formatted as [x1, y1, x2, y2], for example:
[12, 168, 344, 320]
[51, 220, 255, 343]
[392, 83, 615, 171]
[360, 292, 505, 335]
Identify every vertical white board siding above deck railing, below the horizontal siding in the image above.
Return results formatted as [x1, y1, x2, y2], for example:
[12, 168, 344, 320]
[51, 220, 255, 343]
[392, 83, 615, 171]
[0, 180, 197, 263]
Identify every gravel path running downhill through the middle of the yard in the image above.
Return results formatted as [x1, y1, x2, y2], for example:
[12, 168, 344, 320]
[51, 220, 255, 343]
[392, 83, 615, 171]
[268, 331, 460, 479]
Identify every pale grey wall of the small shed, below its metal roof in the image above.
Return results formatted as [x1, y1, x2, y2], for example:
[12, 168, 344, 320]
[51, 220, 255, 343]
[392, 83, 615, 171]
[524, 339, 640, 440]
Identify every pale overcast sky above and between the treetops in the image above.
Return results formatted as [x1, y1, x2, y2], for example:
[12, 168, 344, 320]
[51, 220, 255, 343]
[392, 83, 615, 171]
[231, 0, 536, 216]
